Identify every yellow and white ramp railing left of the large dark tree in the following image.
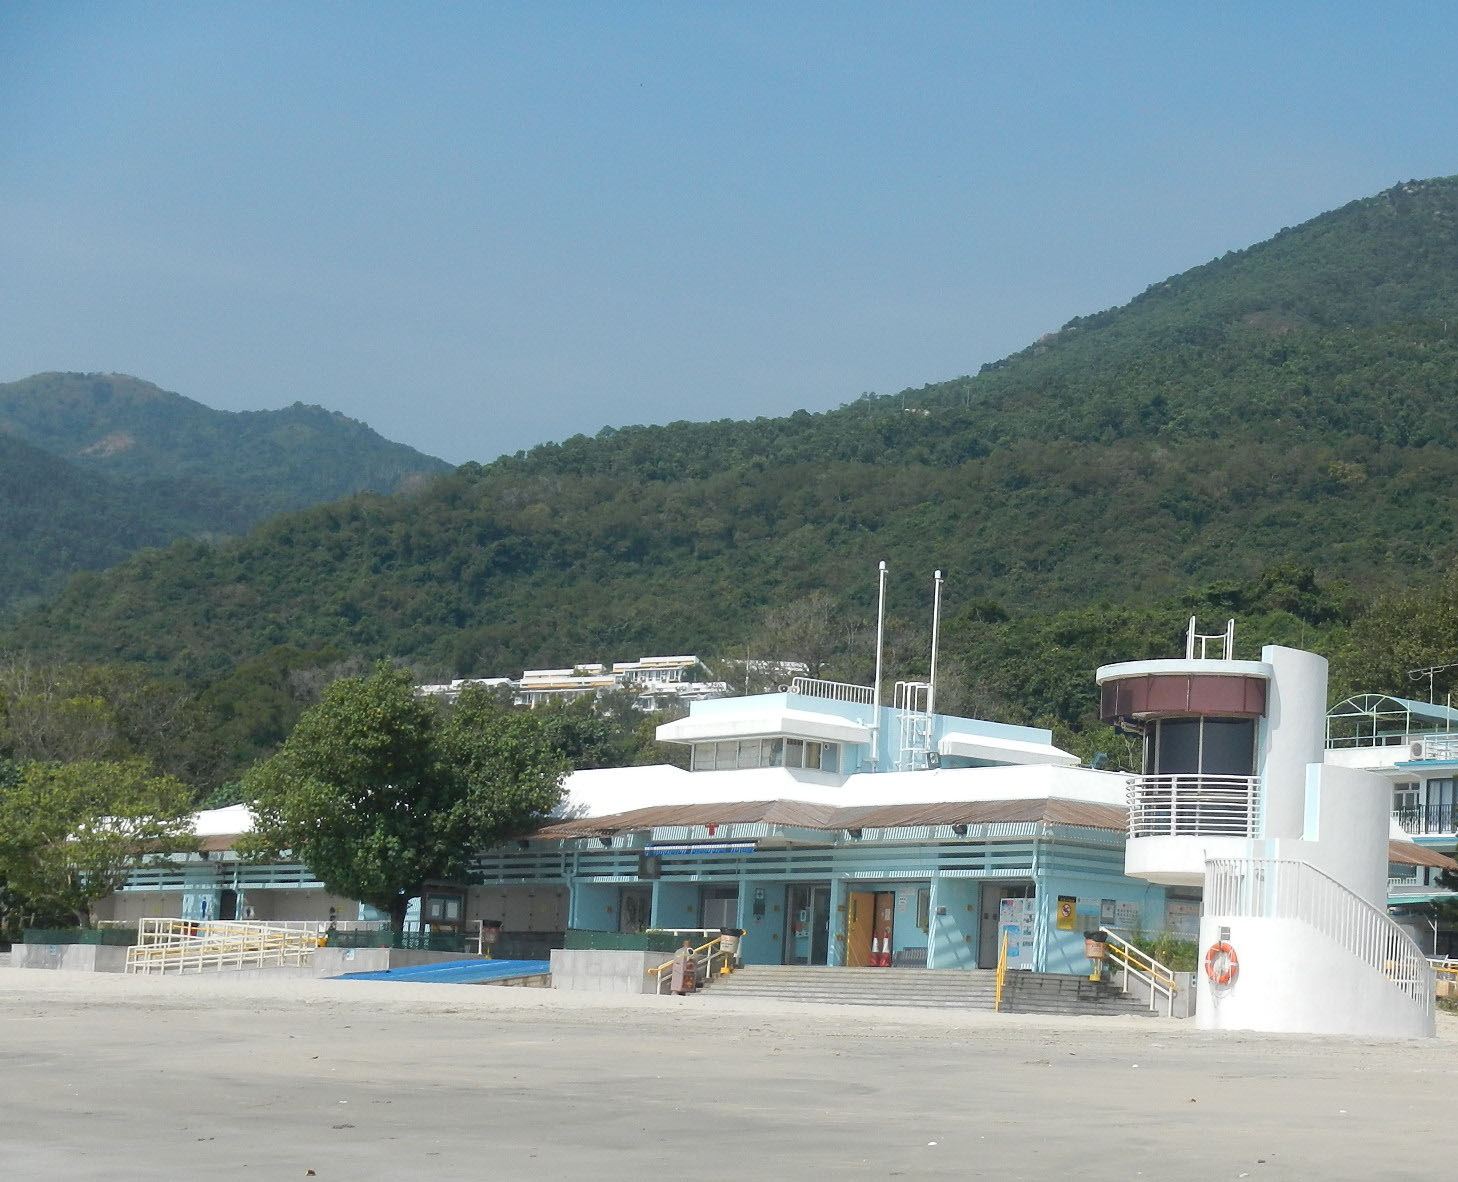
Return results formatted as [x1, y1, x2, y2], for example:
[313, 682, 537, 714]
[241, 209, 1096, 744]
[125, 918, 321, 974]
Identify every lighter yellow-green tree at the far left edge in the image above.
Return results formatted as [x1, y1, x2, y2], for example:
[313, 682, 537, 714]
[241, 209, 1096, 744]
[0, 759, 195, 924]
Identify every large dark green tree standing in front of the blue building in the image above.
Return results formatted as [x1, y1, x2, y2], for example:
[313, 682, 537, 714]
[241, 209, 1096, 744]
[243, 665, 566, 931]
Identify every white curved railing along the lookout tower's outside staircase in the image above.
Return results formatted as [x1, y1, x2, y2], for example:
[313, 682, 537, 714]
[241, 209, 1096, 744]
[1204, 858, 1435, 1014]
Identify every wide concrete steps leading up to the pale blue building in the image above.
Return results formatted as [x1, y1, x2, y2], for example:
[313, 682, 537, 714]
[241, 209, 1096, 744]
[706, 965, 1149, 1014]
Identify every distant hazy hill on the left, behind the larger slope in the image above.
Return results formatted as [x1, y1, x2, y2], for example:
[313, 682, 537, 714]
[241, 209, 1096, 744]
[0, 373, 449, 611]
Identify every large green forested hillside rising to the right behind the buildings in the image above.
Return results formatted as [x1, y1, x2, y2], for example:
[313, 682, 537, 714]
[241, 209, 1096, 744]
[13, 179, 1458, 693]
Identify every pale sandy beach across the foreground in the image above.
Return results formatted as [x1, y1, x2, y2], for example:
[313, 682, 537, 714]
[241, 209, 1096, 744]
[0, 968, 1458, 1182]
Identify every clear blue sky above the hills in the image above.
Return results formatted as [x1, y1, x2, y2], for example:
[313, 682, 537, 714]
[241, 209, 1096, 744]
[0, 0, 1458, 462]
